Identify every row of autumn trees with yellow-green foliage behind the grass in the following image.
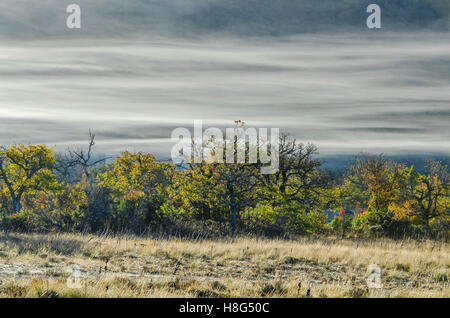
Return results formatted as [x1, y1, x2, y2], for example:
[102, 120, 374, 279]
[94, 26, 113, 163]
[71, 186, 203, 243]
[0, 133, 450, 239]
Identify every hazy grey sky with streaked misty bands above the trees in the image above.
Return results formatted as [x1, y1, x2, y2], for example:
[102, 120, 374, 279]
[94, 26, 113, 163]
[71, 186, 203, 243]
[0, 0, 450, 157]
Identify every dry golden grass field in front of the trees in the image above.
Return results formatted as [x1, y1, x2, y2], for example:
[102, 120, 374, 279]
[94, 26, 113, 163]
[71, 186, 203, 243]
[0, 234, 450, 298]
